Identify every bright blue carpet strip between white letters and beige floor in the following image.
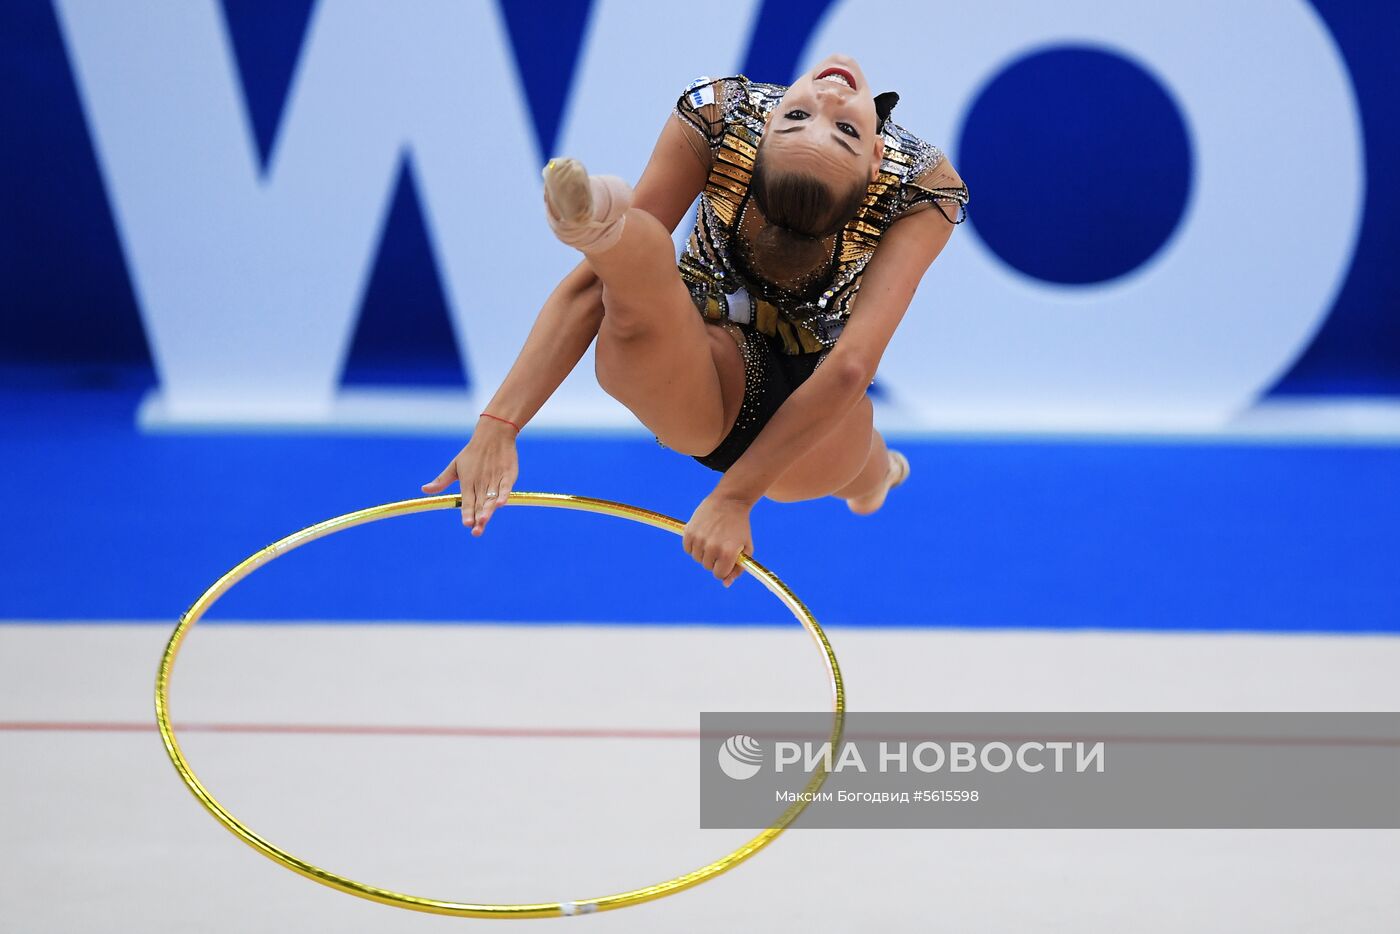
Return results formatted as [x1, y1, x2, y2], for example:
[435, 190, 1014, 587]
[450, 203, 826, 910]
[0, 368, 1400, 632]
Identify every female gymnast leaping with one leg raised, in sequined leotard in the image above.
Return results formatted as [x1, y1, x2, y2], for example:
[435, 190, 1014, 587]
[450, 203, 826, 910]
[421, 55, 967, 587]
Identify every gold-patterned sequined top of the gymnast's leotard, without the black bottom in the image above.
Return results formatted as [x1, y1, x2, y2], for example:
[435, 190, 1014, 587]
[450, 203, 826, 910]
[675, 74, 967, 354]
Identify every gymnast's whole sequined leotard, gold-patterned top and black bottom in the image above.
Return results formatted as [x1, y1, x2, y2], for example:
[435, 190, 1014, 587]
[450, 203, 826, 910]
[658, 74, 967, 472]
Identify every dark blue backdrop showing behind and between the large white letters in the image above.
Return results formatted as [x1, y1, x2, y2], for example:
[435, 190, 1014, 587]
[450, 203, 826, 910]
[0, 0, 1400, 395]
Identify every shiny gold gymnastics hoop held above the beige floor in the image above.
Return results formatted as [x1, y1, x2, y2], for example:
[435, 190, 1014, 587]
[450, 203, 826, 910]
[155, 490, 846, 919]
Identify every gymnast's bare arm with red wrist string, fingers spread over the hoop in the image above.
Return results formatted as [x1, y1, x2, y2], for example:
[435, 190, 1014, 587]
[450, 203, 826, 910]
[421, 118, 708, 535]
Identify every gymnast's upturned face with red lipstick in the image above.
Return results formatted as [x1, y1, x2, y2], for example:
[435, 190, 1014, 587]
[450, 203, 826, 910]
[762, 55, 885, 190]
